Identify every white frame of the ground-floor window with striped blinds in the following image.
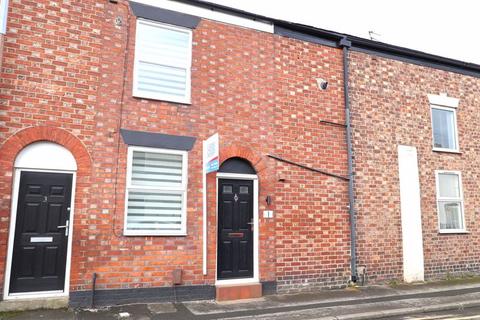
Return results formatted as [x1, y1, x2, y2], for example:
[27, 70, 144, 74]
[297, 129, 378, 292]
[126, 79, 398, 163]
[123, 146, 188, 236]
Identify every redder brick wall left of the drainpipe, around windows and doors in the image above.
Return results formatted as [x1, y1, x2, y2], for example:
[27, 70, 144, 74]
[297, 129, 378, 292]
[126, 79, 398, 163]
[0, 0, 349, 291]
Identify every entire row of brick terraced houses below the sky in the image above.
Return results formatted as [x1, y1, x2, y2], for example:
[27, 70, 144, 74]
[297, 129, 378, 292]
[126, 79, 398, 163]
[0, 0, 480, 306]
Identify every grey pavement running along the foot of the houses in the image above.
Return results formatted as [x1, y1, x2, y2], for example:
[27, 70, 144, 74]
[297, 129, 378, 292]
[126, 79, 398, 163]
[0, 279, 480, 320]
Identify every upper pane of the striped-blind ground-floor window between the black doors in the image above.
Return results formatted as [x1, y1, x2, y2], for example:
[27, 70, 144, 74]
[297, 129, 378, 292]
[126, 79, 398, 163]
[131, 151, 183, 187]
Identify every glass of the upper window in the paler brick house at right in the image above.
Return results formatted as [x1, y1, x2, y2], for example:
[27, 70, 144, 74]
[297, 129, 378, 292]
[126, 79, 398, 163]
[432, 108, 457, 149]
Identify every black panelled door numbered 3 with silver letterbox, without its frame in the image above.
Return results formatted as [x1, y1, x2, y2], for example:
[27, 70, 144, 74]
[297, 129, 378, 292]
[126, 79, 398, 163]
[10, 171, 72, 293]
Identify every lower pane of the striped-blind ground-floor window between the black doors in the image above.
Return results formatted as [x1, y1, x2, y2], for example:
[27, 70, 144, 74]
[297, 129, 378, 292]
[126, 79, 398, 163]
[127, 190, 183, 231]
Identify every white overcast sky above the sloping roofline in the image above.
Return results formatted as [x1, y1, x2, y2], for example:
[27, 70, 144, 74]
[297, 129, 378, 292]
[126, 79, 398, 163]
[207, 0, 480, 64]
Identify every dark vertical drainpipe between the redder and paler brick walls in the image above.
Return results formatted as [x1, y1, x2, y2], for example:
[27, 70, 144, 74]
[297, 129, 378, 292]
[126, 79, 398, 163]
[338, 38, 358, 282]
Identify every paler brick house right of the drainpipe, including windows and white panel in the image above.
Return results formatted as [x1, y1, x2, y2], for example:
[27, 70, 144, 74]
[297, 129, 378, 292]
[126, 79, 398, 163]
[349, 52, 480, 282]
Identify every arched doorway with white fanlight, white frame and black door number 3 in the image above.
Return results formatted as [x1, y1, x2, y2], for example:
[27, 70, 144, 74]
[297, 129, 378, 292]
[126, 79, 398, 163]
[4, 141, 77, 299]
